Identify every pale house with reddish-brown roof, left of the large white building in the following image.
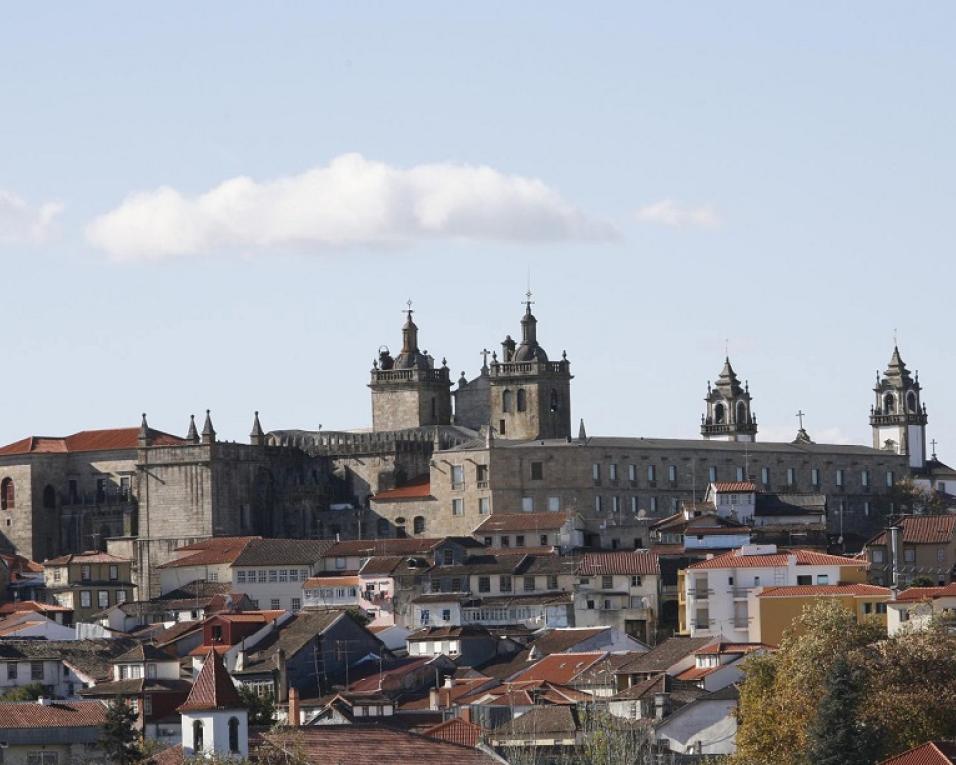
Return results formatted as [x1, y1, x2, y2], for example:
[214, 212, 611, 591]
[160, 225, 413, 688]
[574, 550, 661, 645]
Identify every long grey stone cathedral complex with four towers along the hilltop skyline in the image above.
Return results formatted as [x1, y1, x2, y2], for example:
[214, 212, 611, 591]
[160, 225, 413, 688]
[0, 293, 956, 594]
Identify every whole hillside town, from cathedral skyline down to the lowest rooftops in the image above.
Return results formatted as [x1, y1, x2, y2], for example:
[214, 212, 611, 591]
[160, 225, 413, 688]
[0, 302, 956, 765]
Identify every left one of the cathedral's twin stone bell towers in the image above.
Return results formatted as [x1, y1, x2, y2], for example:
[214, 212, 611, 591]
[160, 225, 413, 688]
[368, 301, 451, 432]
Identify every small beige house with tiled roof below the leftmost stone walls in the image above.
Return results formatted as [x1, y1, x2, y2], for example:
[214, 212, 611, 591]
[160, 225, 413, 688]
[43, 550, 134, 622]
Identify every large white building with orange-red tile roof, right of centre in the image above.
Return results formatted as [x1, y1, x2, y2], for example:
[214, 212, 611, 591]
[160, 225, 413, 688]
[678, 545, 866, 642]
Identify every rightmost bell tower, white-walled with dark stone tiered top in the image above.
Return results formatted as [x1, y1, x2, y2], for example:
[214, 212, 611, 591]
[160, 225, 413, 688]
[870, 345, 926, 468]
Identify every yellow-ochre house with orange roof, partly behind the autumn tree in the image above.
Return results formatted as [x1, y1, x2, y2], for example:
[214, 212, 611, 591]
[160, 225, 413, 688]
[748, 584, 893, 645]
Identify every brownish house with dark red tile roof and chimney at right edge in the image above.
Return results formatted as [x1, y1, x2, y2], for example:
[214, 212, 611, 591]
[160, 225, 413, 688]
[864, 514, 956, 587]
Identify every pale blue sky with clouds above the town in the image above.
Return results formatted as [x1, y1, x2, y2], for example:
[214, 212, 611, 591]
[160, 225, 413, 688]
[0, 1, 956, 450]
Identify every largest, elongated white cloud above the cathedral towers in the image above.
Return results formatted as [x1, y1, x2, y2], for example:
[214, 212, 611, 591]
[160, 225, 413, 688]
[87, 154, 617, 260]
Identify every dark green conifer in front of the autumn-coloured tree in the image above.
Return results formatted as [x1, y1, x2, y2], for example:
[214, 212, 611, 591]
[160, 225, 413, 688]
[807, 656, 878, 765]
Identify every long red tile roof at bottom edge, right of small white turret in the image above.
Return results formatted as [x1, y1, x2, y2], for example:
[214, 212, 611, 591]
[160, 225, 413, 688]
[263, 724, 500, 765]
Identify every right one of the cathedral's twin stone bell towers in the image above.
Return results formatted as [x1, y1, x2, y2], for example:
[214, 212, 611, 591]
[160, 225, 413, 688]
[488, 292, 571, 439]
